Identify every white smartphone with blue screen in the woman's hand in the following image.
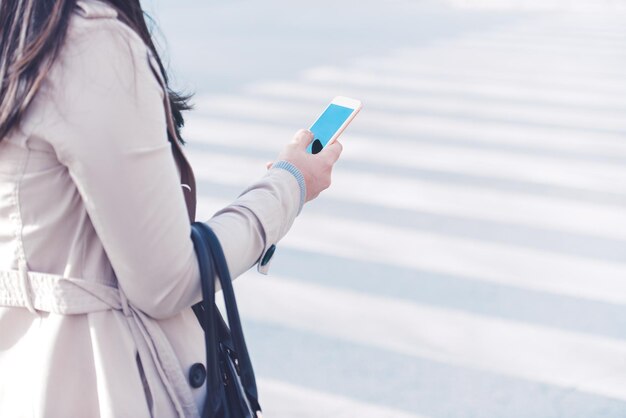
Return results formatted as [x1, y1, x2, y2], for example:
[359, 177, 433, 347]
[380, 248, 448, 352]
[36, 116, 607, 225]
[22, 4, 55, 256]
[307, 96, 363, 154]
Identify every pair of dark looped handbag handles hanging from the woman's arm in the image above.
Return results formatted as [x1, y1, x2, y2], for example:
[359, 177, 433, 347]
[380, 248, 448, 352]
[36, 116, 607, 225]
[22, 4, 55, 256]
[192, 222, 261, 411]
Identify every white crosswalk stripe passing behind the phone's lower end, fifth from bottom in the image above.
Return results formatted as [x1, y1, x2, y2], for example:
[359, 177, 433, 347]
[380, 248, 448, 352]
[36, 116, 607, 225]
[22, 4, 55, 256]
[185, 115, 626, 194]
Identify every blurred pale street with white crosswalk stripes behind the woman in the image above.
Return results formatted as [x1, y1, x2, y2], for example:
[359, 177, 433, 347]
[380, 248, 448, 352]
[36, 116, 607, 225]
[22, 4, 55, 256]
[147, 0, 626, 418]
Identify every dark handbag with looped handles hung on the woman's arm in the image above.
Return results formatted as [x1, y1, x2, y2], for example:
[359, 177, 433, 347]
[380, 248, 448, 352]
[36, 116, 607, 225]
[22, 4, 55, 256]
[191, 222, 262, 418]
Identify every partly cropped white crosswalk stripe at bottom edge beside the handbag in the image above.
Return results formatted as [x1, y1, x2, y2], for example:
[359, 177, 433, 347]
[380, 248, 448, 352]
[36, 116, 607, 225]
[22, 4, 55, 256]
[259, 379, 426, 418]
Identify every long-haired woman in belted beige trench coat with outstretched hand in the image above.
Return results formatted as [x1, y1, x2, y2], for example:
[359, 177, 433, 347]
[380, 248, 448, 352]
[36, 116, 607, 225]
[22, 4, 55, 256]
[0, 0, 341, 418]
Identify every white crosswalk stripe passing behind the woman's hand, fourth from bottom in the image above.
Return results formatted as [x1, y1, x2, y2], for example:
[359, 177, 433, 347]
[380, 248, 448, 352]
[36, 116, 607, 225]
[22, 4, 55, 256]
[190, 151, 626, 240]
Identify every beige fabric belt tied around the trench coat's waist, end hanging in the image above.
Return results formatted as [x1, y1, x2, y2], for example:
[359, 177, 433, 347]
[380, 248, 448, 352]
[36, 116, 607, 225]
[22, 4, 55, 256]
[0, 270, 199, 418]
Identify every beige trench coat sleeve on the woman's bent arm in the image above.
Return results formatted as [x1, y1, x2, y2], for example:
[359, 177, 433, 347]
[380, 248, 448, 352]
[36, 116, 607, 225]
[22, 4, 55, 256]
[41, 15, 300, 318]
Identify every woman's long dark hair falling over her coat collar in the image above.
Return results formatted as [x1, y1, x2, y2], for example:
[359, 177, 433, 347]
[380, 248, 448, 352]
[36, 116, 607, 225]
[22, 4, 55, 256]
[0, 0, 191, 143]
